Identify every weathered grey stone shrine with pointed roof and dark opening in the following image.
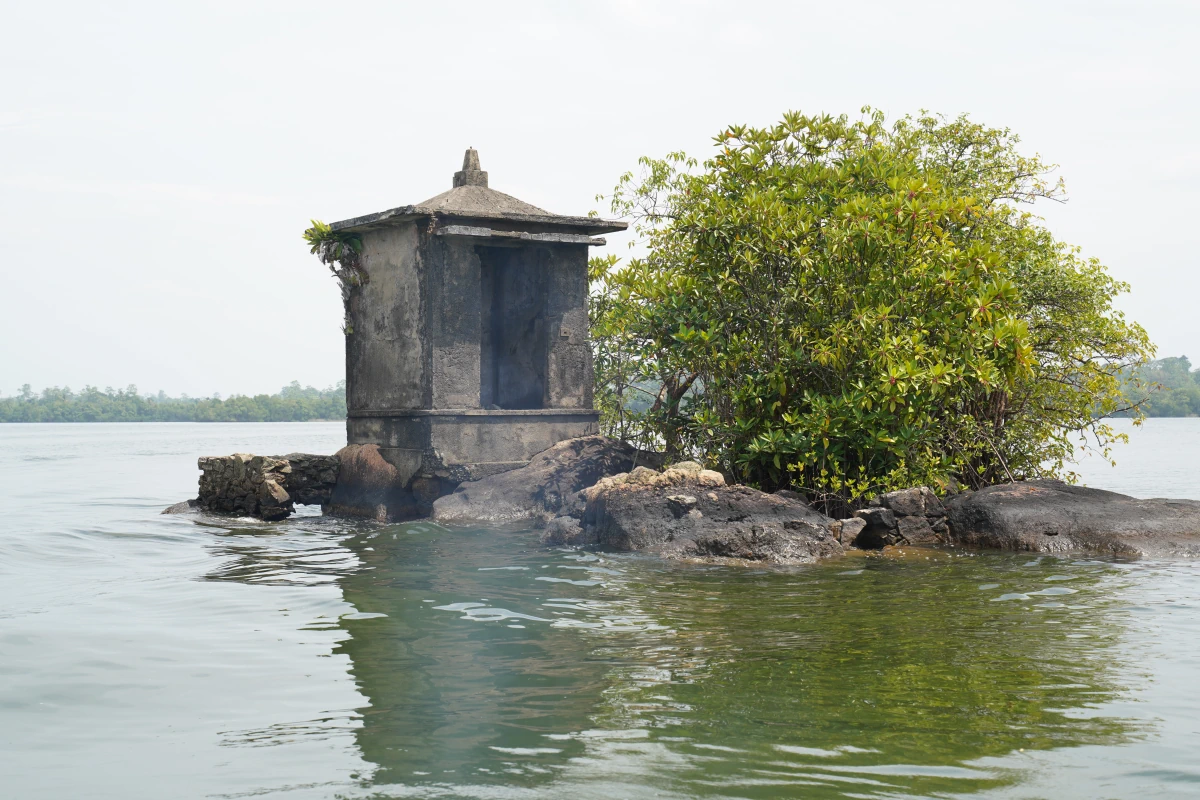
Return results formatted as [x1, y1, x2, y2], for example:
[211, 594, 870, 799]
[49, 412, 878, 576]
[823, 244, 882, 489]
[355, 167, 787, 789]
[331, 149, 626, 517]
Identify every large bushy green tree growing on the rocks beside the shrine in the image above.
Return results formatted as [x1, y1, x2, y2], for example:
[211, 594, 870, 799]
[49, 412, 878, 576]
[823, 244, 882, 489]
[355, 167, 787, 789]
[592, 109, 1153, 504]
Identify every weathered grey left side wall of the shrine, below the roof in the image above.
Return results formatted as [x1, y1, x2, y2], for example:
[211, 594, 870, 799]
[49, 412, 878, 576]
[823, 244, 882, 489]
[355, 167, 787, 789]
[346, 223, 427, 409]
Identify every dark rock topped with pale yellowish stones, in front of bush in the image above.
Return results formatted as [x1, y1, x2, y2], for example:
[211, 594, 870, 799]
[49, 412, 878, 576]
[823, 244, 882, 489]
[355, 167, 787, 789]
[559, 462, 844, 564]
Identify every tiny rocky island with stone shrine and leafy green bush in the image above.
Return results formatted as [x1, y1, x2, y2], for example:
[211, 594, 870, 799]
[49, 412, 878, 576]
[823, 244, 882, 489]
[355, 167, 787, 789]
[167, 122, 1200, 564]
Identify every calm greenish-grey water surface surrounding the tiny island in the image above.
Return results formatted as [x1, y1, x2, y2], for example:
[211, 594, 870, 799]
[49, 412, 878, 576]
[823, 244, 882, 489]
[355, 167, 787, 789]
[0, 420, 1200, 800]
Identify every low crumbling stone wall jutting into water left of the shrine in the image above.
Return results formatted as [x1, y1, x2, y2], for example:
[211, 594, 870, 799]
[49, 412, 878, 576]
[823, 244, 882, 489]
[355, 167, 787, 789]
[184, 453, 340, 522]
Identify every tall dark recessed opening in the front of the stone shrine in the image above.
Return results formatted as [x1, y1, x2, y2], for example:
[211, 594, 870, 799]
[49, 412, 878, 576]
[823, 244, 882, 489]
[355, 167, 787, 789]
[475, 247, 546, 409]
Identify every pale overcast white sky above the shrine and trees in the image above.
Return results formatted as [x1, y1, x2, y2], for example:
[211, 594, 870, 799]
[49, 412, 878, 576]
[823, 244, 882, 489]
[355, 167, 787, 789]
[0, 0, 1200, 396]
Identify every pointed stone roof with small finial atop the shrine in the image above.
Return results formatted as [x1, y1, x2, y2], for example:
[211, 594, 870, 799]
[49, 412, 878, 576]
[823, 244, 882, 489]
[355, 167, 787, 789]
[330, 148, 628, 234]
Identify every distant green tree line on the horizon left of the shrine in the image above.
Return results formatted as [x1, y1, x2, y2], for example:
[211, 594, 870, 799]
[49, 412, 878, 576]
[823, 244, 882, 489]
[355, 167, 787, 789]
[0, 380, 346, 422]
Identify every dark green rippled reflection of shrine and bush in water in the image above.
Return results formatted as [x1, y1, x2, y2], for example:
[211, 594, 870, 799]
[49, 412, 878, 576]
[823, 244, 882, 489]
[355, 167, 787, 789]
[209, 519, 1142, 798]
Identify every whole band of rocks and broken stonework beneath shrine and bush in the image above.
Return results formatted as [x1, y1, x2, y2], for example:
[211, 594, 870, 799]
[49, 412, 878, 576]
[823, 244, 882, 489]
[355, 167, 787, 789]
[166, 435, 1200, 564]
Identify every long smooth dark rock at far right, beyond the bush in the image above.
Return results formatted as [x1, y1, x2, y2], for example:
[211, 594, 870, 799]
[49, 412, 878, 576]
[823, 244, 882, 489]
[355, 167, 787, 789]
[946, 480, 1200, 558]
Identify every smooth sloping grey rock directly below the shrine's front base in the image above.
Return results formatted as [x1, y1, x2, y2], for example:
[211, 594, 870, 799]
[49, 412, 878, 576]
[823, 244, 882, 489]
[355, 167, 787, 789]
[432, 435, 638, 524]
